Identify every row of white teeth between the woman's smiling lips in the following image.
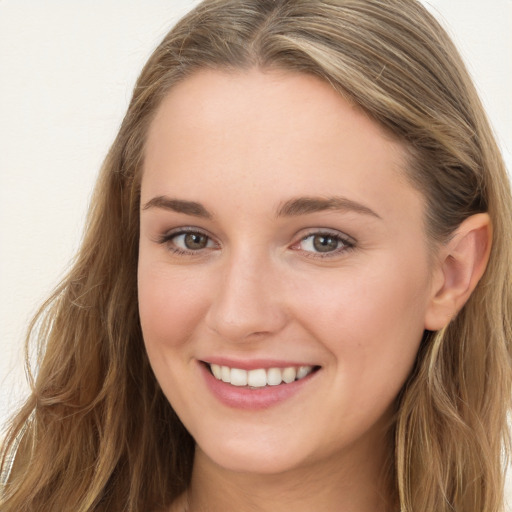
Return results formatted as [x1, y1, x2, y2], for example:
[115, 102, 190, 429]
[205, 363, 320, 389]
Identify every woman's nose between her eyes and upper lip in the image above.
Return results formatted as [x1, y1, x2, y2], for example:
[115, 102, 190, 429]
[205, 250, 287, 341]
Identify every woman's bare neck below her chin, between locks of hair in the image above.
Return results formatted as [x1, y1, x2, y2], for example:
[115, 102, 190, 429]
[187, 434, 396, 512]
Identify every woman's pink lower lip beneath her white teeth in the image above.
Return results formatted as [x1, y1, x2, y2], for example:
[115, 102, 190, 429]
[199, 363, 318, 410]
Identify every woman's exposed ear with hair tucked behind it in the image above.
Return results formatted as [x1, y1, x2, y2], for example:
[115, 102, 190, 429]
[425, 213, 492, 331]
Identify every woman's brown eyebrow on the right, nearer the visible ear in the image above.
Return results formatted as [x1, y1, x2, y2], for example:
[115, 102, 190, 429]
[277, 196, 382, 219]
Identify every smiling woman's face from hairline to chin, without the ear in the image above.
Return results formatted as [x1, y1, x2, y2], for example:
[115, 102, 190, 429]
[138, 70, 433, 473]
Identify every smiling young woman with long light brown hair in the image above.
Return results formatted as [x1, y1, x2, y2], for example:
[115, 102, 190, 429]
[0, 0, 512, 512]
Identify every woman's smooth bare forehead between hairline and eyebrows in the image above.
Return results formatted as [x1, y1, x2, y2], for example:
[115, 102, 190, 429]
[142, 69, 417, 224]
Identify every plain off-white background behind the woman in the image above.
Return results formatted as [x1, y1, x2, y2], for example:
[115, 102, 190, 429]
[0, 0, 512, 500]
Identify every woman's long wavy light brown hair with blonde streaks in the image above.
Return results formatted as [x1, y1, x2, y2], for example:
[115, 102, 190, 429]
[0, 0, 512, 512]
